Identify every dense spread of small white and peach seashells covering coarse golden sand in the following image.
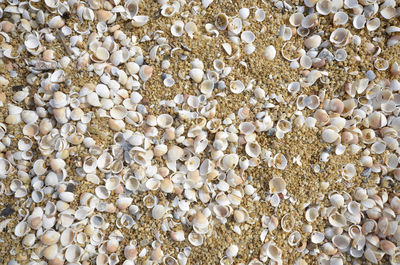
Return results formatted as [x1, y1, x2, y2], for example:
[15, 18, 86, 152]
[0, 0, 400, 265]
